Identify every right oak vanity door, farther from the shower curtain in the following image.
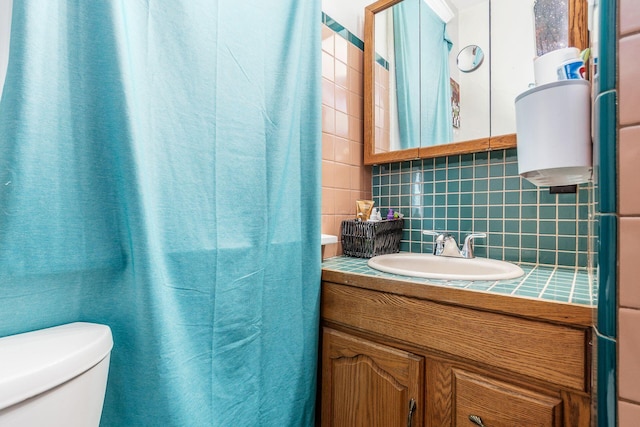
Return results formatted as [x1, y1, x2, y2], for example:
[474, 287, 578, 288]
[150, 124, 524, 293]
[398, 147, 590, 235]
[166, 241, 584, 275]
[453, 369, 562, 427]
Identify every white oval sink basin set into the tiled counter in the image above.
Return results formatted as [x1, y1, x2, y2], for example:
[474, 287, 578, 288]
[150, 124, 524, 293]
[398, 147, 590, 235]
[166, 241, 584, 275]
[368, 252, 524, 280]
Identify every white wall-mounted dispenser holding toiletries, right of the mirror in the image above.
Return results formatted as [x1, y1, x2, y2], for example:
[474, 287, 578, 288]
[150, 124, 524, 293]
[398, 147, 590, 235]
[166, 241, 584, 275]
[516, 79, 592, 187]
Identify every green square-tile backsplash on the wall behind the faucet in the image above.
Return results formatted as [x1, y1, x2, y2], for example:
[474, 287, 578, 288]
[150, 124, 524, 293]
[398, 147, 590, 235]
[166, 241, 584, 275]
[372, 149, 594, 267]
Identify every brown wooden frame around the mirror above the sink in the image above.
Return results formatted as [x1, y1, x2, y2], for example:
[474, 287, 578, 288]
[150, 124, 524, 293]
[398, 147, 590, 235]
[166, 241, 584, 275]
[364, 0, 589, 165]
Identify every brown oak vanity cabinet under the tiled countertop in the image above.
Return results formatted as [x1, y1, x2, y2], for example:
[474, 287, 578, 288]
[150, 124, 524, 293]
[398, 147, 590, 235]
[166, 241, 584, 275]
[320, 279, 591, 427]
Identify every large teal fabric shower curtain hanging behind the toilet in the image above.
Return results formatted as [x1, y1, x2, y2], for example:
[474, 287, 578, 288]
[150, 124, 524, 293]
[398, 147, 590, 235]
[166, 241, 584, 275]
[0, 0, 321, 427]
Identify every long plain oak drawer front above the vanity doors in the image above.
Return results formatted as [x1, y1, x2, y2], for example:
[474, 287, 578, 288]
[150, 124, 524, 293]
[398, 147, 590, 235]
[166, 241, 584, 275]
[321, 281, 589, 391]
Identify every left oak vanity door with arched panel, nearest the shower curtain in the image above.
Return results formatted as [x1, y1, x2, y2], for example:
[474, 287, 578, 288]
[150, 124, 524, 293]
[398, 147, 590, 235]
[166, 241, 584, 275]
[321, 328, 424, 427]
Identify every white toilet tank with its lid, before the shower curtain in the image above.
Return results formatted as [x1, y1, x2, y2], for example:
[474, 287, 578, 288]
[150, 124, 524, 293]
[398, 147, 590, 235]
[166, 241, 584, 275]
[0, 323, 113, 427]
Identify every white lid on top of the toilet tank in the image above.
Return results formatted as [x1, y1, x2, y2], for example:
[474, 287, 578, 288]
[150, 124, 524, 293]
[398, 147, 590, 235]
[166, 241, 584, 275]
[0, 322, 113, 410]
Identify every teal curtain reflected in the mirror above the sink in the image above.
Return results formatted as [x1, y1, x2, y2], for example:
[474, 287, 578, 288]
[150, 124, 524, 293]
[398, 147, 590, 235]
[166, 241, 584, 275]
[393, 0, 453, 148]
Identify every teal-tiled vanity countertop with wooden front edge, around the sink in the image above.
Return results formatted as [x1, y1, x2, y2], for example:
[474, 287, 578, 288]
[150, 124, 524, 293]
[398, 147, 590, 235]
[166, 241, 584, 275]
[322, 256, 597, 325]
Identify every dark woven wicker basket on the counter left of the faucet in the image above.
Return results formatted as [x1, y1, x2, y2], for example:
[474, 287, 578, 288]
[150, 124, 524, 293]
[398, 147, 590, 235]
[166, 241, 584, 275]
[340, 219, 404, 258]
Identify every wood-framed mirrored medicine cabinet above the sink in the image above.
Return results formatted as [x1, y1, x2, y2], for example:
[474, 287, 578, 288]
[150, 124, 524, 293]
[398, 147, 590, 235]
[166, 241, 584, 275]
[364, 0, 588, 164]
